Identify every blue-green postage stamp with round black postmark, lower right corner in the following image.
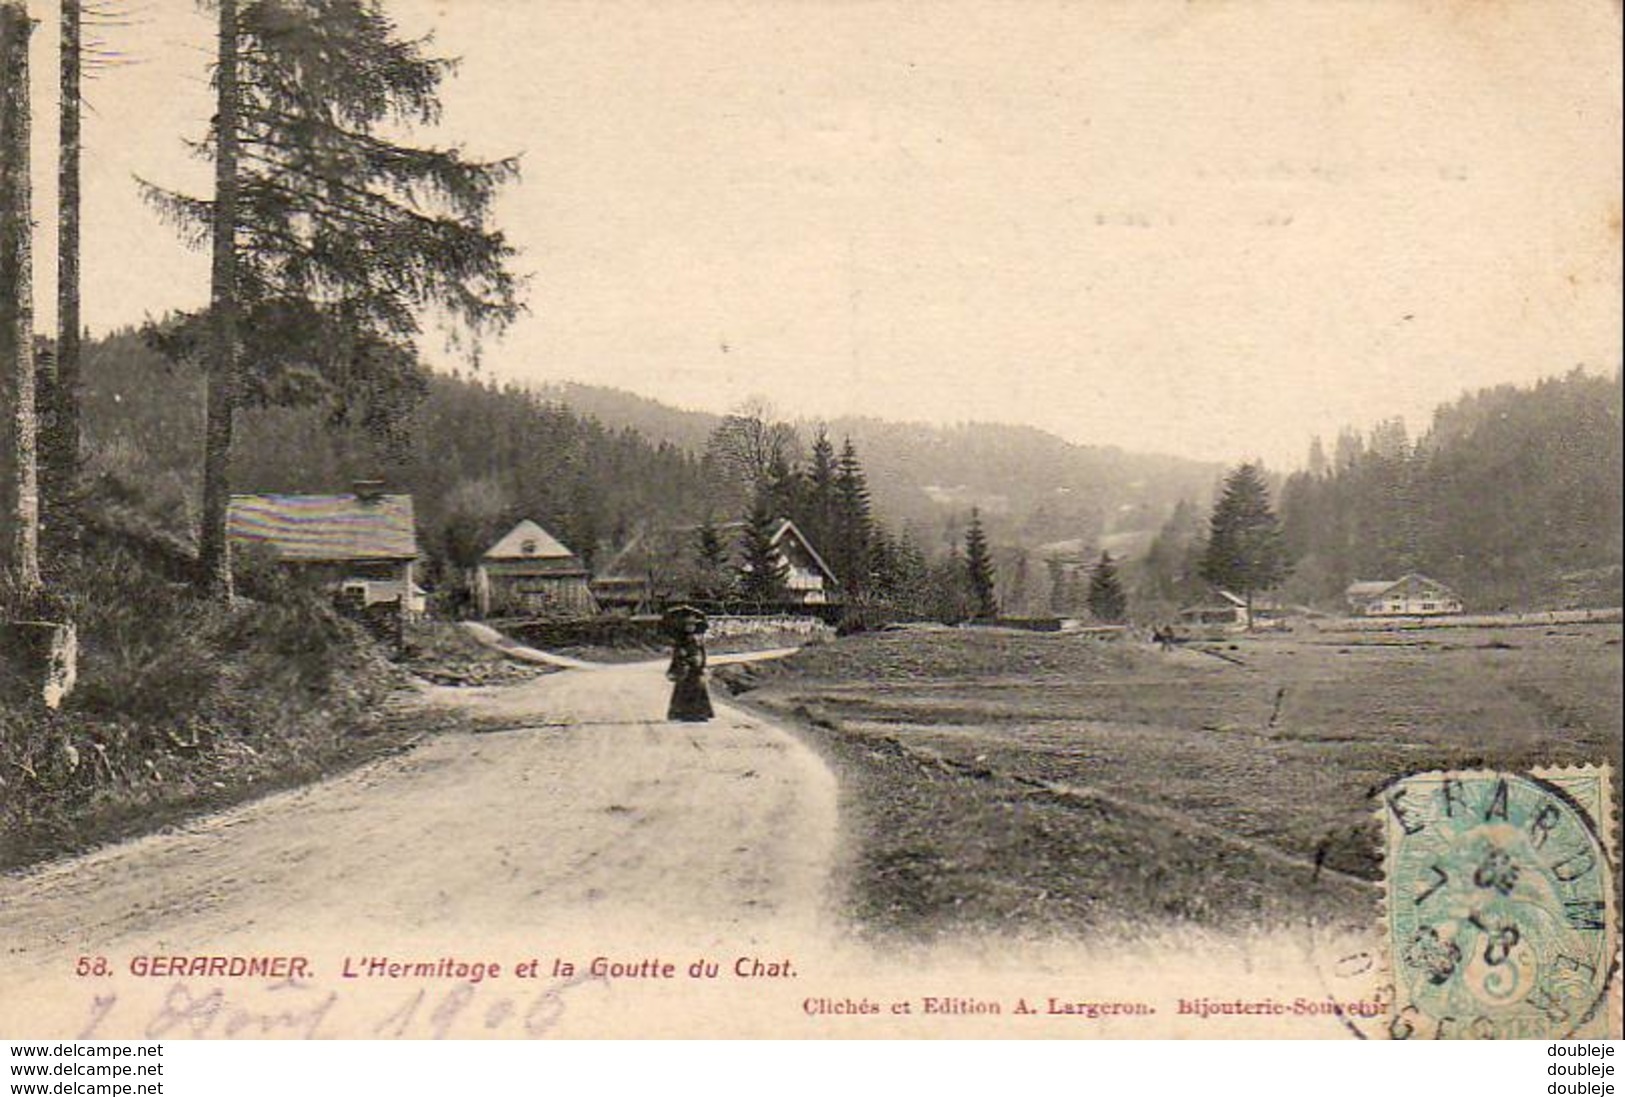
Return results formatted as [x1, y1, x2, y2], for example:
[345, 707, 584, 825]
[1381, 765, 1619, 1038]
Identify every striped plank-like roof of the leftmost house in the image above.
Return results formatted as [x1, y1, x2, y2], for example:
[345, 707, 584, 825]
[226, 496, 418, 562]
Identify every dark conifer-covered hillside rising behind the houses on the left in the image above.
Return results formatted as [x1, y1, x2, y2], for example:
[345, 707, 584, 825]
[0, 330, 705, 578]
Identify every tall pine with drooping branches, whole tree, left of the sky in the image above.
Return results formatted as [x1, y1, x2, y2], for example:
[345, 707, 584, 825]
[148, 0, 520, 596]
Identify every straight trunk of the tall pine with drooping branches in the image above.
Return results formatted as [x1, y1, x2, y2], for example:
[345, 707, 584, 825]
[198, 0, 237, 601]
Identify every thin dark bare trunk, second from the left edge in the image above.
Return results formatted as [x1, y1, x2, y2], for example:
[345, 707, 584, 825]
[46, 0, 83, 541]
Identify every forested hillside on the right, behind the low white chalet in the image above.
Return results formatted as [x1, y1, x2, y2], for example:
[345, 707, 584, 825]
[1136, 371, 1622, 611]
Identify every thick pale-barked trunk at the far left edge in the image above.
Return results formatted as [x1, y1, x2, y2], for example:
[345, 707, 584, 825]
[0, 0, 41, 596]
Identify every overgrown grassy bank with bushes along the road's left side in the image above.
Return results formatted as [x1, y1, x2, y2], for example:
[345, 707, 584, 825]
[0, 541, 487, 869]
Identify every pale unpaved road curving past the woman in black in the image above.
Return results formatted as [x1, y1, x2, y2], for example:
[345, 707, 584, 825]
[0, 665, 835, 996]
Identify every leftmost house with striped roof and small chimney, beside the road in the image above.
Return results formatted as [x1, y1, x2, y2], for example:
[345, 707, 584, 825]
[226, 481, 423, 614]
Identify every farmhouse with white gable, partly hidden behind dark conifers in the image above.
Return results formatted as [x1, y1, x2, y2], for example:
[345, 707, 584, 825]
[592, 518, 840, 613]
